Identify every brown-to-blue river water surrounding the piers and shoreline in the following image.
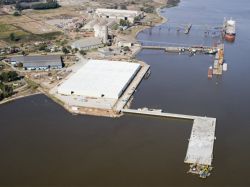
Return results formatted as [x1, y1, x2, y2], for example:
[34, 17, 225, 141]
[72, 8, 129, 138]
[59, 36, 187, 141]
[0, 0, 250, 186]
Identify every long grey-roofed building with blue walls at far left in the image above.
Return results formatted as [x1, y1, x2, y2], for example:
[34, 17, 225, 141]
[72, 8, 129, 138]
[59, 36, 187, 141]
[10, 55, 62, 70]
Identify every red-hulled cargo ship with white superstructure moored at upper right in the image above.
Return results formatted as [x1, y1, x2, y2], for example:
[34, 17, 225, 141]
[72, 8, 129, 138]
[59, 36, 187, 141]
[224, 18, 236, 42]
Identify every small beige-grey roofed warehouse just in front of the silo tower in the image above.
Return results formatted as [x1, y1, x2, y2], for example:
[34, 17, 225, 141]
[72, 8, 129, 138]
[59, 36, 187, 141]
[71, 37, 104, 50]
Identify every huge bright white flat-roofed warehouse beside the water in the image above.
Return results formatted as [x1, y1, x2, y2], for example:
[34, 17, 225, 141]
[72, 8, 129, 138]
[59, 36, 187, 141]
[57, 60, 141, 99]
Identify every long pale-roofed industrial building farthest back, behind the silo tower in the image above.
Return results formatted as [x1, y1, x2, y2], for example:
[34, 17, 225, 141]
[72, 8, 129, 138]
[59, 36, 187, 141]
[96, 8, 144, 23]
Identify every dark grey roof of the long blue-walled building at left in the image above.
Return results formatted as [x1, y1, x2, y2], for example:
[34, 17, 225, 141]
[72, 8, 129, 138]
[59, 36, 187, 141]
[10, 55, 62, 67]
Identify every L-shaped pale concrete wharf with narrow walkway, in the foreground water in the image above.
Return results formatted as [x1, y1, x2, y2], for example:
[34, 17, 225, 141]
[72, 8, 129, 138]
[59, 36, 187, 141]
[121, 108, 216, 166]
